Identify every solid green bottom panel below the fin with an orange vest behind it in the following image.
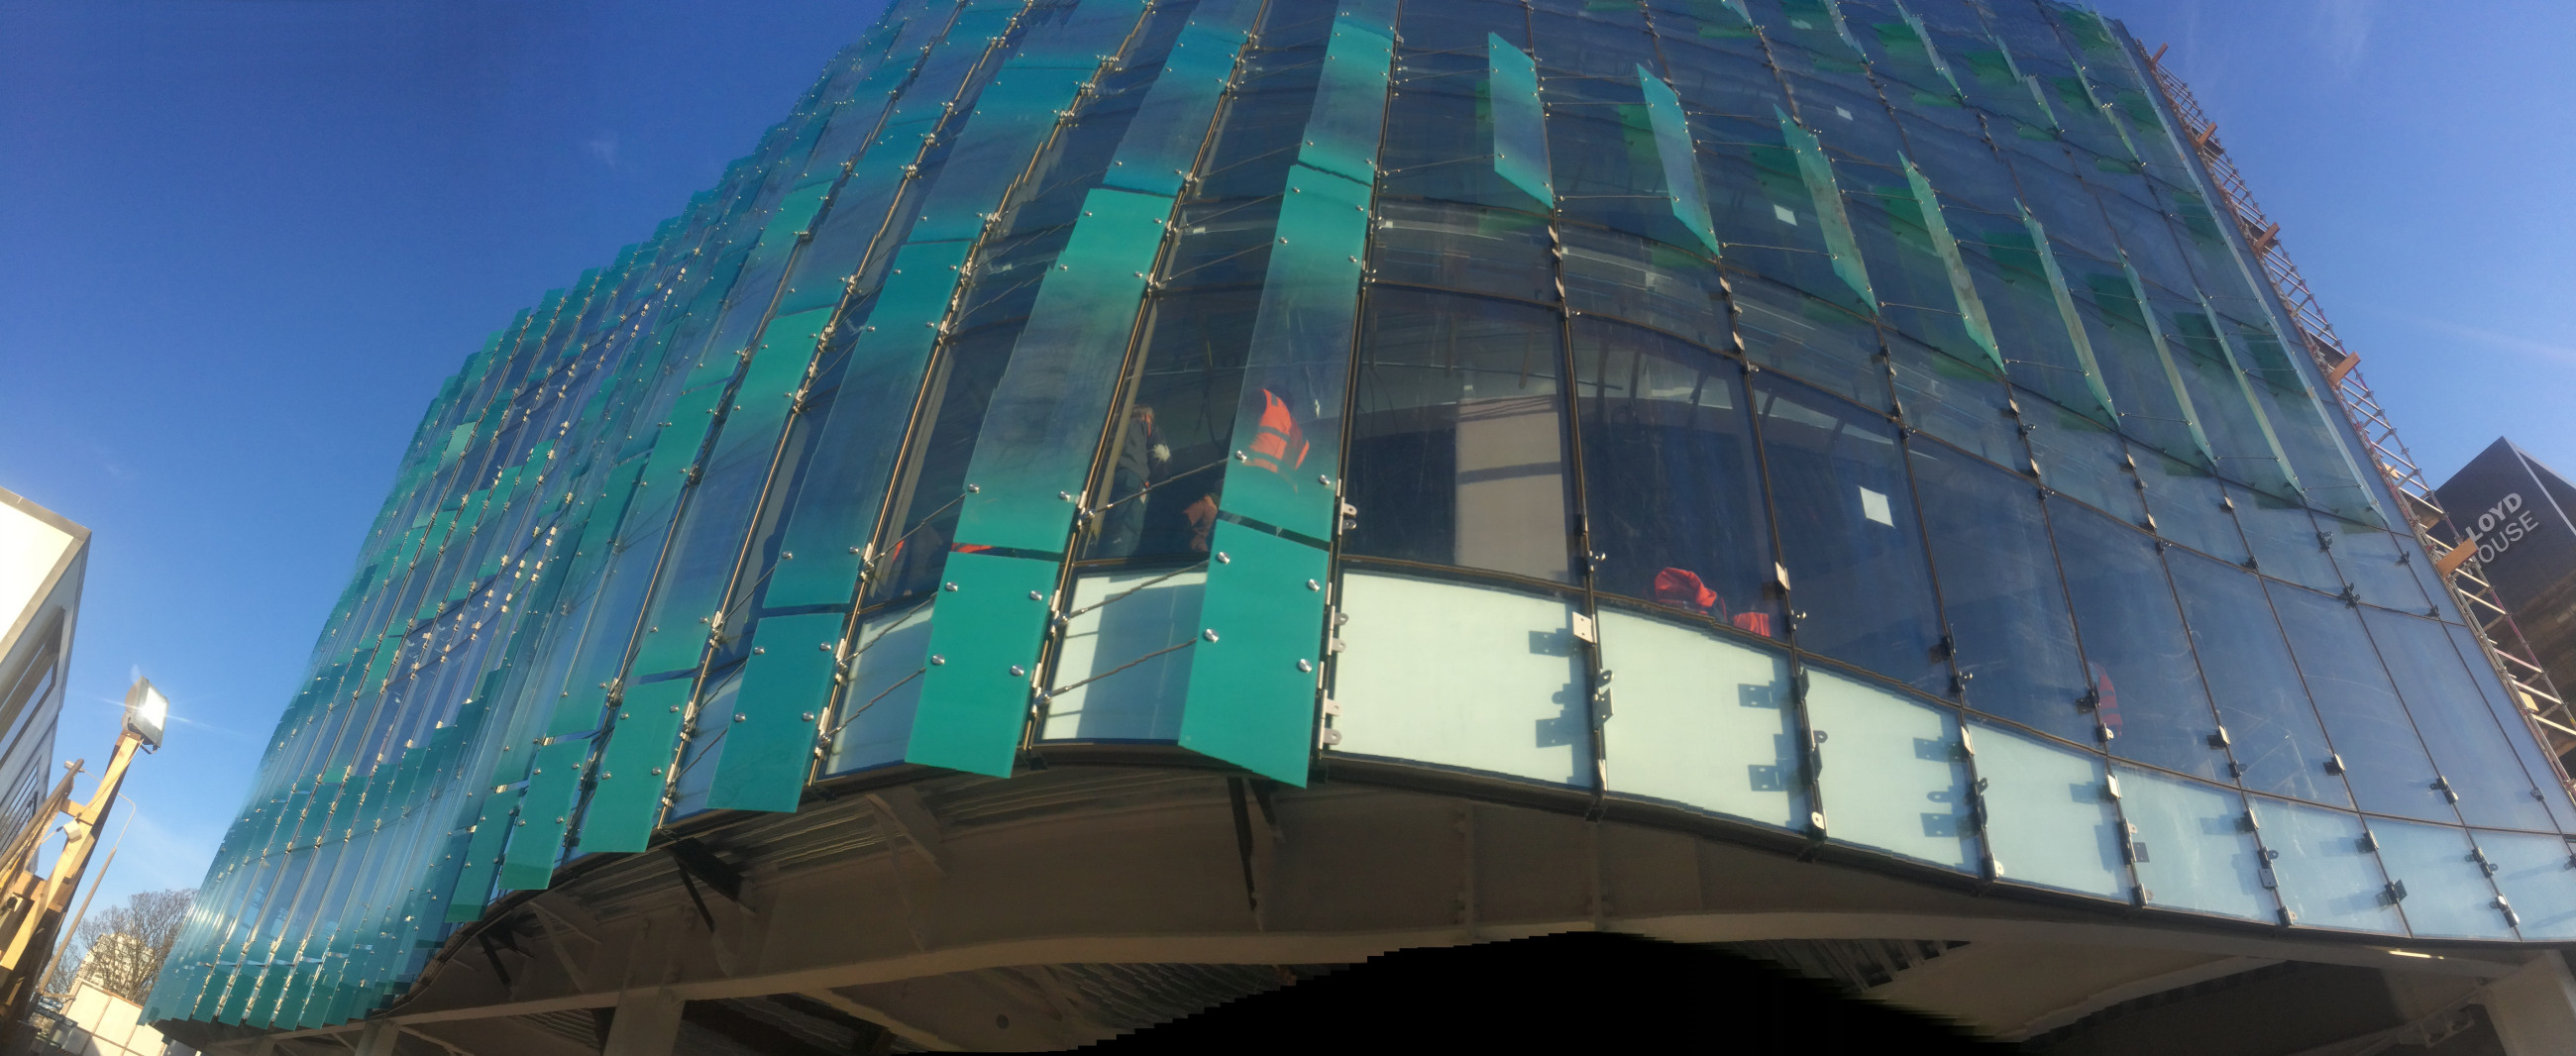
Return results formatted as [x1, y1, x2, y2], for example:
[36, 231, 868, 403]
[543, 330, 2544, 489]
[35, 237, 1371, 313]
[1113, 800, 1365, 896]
[1180, 520, 1332, 786]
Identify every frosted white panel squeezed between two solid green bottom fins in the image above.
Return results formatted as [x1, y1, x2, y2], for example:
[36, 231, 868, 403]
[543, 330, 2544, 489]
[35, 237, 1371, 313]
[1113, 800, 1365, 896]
[1038, 570, 1208, 742]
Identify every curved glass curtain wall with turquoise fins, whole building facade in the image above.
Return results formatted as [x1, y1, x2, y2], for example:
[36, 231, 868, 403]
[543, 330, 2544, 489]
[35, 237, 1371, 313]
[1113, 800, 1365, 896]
[147, 0, 2576, 1027]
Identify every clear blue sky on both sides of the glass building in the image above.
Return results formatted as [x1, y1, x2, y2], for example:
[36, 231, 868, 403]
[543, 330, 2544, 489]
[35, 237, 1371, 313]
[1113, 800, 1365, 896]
[0, 0, 2576, 921]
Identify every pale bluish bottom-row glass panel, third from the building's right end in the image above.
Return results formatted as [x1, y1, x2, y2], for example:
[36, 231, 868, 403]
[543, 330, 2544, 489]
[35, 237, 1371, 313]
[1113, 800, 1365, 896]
[2246, 795, 2406, 935]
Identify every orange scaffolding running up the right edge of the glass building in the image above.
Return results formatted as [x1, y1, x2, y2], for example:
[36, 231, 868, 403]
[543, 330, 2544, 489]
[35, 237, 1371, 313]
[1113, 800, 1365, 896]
[2146, 49, 2576, 783]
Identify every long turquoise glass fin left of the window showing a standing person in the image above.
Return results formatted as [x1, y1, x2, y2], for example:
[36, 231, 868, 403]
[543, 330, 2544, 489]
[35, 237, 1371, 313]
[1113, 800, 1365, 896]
[956, 190, 1172, 554]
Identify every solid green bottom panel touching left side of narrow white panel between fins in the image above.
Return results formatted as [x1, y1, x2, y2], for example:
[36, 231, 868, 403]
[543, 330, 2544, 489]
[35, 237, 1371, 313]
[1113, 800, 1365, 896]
[905, 551, 1059, 778]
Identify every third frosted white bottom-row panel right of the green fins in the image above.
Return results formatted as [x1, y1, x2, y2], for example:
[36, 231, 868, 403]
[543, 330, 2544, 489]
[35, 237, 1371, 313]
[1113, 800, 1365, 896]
[1806, 670, 1976, 871]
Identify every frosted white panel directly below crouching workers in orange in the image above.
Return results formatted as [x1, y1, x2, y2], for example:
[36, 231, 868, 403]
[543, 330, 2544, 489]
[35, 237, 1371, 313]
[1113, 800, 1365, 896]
[1602, 608, 1808, 827]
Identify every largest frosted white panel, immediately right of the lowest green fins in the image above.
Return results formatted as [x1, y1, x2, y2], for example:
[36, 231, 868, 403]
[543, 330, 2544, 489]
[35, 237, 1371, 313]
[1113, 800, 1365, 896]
[1332, 572, 1592, 786]
